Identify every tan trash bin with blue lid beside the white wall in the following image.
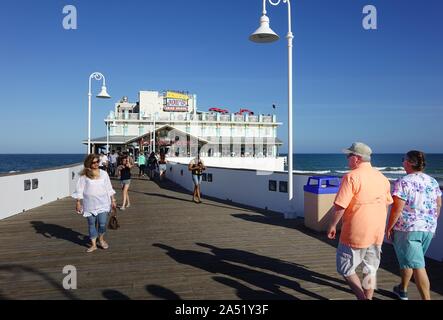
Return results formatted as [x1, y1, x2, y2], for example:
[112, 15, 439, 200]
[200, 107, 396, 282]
[303, 176, 340, 232]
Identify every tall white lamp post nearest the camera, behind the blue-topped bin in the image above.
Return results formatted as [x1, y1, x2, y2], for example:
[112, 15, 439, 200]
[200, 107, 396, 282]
[249, 0, 294, 200]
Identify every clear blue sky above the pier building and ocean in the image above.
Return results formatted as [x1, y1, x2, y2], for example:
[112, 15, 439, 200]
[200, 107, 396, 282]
[0, 0, 443, 153]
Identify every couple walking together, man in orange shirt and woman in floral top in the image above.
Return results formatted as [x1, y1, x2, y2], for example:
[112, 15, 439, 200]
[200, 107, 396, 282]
[327, 142, 442, 300]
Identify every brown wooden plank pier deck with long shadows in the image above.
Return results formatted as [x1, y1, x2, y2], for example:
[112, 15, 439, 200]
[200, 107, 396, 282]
[0, 179, 443, 300]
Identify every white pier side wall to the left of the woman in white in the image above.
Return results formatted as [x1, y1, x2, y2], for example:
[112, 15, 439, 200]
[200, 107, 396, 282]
[0, 165, 83, 219]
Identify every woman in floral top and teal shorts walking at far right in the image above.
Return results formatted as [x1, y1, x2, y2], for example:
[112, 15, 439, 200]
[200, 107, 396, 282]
[386, 150, 442, 300]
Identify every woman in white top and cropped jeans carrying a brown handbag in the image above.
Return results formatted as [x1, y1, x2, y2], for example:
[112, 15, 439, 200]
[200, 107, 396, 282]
[72, 154, 116, 252]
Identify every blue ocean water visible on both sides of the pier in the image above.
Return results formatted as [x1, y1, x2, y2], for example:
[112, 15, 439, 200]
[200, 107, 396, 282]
[0, 154, 443, 186]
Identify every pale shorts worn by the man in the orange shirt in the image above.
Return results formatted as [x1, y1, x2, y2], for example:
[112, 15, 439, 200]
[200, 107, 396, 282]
[337, 243, 381, 277]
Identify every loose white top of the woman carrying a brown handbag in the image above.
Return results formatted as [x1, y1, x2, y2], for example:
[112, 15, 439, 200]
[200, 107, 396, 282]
[72, 170, 115, 217]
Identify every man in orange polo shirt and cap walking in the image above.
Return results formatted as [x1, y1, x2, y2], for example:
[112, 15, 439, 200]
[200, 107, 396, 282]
[328, 142, 393, 300]
